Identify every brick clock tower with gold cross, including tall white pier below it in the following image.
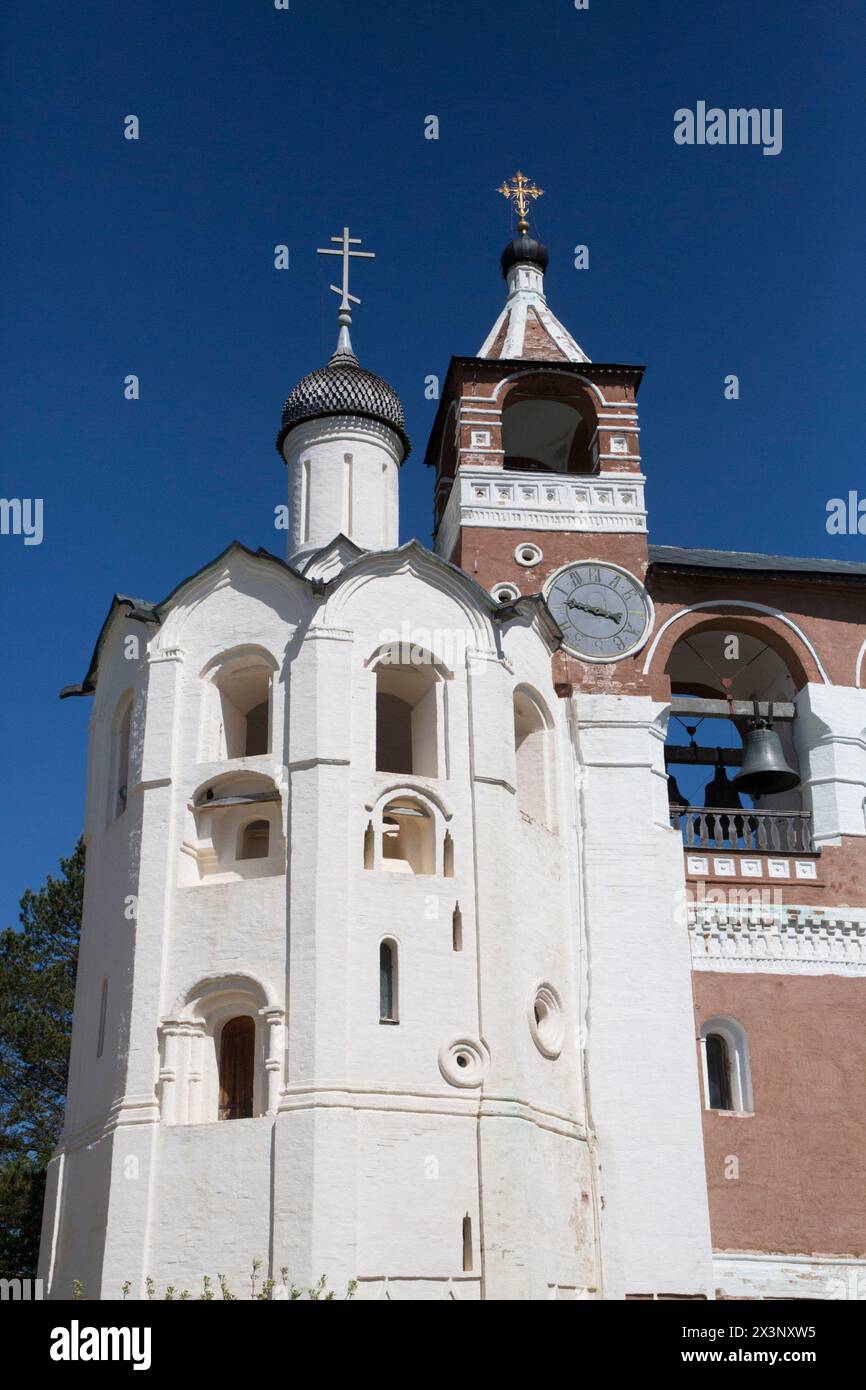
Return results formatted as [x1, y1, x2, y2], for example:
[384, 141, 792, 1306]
[427, 172, 712, 1298]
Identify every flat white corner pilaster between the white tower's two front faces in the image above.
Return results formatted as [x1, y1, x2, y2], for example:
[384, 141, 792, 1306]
[271, 625, 361, 1289]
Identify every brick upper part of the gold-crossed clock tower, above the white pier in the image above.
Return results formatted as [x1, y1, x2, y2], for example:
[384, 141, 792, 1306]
[425, 172, 651, 689]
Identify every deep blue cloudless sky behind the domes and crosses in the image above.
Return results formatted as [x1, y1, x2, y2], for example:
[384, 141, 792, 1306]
[0, 0, 866, 923]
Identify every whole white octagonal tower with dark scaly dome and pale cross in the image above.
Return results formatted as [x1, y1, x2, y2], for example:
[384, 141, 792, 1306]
[42, 211, 601, 1300]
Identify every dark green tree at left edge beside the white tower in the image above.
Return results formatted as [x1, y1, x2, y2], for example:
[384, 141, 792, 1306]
[0, 840, 85, 1277]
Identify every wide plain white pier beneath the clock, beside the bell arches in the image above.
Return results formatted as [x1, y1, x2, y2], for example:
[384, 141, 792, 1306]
[571, 694, 712, 1298]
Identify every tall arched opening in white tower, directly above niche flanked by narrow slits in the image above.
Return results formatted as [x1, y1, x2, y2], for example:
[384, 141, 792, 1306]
[375, 649, 445, 777]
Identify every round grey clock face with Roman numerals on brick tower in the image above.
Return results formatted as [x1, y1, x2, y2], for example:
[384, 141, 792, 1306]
[546, 560, 652, 662]
